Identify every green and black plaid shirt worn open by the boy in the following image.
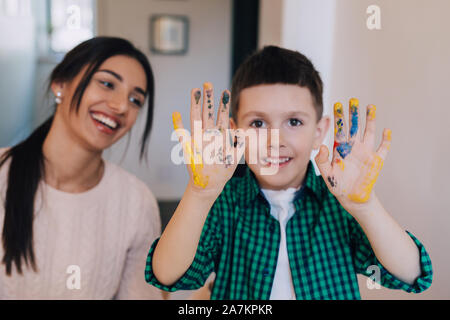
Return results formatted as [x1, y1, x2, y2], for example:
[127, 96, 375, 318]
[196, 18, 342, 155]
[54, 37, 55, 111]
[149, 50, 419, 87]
[145, 162, 433, 300]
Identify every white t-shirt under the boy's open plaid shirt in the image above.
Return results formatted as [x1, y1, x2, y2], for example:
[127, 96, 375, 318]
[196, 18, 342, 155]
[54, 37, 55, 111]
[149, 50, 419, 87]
[261, 188, 300, 300]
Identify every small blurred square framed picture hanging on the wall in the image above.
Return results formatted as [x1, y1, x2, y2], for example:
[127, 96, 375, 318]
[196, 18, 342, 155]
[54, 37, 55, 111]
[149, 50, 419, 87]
[150, 14, 189, 55]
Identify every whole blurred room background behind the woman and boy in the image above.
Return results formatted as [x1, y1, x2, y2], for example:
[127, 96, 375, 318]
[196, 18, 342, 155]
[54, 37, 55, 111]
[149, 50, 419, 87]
[0, 0, 450, 299]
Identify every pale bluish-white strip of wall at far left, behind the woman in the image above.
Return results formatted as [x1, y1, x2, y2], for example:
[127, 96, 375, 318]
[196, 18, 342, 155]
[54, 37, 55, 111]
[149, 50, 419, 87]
[0, 1, 36, 147]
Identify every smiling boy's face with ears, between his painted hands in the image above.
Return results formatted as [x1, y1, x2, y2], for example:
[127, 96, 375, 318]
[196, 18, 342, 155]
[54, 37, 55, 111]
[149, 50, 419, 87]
[231, 84, 330, 190]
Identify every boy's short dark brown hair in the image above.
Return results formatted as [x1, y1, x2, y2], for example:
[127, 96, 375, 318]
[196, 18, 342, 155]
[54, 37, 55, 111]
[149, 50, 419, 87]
[231, 46, 323, 121]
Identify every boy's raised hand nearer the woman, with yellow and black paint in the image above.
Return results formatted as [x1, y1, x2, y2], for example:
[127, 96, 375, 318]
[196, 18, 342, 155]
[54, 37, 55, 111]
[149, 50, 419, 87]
[172, 82, 244, 197]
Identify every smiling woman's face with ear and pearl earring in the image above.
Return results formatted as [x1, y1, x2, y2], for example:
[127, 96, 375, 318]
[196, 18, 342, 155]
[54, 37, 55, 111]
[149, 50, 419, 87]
[52, 55, 147, 152]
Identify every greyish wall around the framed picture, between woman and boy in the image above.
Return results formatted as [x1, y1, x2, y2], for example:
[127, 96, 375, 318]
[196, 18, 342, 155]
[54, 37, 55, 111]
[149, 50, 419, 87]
[98, 0, 232, 199]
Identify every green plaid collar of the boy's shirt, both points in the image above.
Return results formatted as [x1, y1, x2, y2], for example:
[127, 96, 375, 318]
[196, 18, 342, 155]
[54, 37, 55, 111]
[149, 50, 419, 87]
[238, 161, 327, 210]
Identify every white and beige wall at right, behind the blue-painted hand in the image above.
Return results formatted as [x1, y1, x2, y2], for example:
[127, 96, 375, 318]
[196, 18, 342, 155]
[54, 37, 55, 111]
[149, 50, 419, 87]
[262, 0, 450, 299]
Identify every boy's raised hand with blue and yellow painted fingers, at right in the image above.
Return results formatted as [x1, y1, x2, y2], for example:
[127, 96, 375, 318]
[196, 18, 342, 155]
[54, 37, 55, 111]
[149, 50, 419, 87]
[315, 98, 391, 215]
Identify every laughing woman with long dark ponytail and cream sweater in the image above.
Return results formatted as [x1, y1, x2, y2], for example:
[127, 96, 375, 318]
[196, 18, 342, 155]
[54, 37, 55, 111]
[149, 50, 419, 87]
[0, 37, 161, 299]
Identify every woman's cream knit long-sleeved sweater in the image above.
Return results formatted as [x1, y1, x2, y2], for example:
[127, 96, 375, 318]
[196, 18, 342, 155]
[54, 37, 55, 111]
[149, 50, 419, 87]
[0, 149, 162, 299]
